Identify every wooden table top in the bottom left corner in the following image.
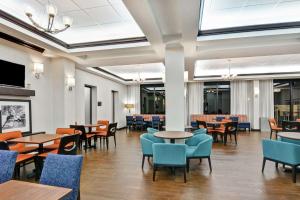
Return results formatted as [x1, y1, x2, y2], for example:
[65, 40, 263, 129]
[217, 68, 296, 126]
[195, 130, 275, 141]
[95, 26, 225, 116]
[0, 180, 72, 200]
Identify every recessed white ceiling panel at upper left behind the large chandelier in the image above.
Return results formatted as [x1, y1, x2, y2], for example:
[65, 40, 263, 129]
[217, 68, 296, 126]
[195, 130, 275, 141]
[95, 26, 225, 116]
[0, 0, 144, 44]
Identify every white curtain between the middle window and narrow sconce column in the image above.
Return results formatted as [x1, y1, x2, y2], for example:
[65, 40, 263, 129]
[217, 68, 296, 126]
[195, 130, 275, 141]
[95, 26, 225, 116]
[230, 81, 254, 124]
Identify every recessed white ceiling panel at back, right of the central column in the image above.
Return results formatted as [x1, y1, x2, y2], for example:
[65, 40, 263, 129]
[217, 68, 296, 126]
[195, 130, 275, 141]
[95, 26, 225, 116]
[194, 54, 300, 76]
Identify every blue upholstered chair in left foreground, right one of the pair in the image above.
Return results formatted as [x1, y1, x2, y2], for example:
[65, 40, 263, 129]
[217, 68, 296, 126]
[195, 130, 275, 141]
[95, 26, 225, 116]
[40, 154, 82, 200]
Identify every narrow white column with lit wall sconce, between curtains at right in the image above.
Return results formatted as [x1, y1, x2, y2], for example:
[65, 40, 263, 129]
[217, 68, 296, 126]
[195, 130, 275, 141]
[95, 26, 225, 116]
[252, 80, 260, 129]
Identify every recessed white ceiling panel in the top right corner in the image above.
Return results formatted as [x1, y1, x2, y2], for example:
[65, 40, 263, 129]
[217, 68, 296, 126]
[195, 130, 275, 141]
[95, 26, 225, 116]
[199, 0, 300, 30]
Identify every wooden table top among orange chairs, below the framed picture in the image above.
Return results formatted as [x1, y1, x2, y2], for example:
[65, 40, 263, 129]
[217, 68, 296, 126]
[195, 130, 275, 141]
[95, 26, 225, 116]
[8, 134, 64, 144]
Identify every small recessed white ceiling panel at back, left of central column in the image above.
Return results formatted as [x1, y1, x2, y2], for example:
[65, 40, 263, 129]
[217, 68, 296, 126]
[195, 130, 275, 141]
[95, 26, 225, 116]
[101, 63, 165, 79]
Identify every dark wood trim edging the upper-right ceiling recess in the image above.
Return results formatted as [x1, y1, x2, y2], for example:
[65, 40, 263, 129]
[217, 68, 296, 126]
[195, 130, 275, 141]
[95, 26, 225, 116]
[198, 22, 300, 36]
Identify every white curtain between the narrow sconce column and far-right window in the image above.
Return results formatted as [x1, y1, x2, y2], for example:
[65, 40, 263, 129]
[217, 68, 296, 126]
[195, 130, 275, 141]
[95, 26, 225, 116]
[259, 80, 274, 118]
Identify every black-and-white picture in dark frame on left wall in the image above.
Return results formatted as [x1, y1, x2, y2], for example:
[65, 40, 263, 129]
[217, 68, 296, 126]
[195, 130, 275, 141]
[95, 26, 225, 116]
[0, 99, 32, 133]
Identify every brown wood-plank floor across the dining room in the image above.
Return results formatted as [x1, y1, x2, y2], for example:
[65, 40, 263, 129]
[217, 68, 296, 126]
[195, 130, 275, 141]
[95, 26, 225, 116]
[22, 131, 300, 200]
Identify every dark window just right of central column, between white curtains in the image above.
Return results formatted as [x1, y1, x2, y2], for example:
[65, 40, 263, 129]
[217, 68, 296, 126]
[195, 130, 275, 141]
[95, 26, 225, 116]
[204, 82, 230, 114]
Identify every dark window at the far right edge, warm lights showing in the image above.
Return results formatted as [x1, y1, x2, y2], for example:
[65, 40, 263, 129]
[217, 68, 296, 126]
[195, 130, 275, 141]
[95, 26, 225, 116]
[273, 79, 300, 123]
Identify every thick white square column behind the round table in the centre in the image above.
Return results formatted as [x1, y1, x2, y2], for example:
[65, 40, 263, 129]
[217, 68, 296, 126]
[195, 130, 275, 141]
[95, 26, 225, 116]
[165, 43, 185, 131]
